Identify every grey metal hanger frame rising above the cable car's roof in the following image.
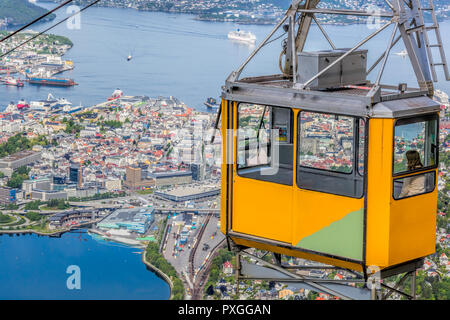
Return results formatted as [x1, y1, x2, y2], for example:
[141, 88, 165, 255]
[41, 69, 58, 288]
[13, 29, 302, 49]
[223, 0, 450, 106]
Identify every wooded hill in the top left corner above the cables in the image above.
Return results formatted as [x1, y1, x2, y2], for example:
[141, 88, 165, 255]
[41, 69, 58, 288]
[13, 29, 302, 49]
[0, 0, 56, 26]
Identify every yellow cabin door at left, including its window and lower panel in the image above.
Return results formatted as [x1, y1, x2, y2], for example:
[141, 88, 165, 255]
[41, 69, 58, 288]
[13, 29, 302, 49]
[229, 103, 294, 244]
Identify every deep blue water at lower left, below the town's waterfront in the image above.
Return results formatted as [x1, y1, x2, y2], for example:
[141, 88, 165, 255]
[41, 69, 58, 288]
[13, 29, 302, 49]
[0, 232, 170, 300]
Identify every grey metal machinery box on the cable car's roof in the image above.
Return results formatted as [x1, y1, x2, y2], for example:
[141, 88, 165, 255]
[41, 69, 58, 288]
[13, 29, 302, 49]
[297, 49, 367, 89]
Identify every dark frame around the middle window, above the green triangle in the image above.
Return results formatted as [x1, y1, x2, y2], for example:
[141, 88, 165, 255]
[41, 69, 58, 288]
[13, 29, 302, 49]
[295, 110, 369, 199]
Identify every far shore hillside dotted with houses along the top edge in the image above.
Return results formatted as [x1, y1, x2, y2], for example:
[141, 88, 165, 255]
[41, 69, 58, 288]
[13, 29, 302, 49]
[29, 0, 450, 24]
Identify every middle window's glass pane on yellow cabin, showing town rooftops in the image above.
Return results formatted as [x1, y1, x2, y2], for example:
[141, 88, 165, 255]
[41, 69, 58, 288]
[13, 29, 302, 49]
[299, 112, 354, 173]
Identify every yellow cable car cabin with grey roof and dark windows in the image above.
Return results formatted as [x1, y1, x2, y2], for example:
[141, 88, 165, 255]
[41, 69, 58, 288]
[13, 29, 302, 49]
[221, 76, 440, 271]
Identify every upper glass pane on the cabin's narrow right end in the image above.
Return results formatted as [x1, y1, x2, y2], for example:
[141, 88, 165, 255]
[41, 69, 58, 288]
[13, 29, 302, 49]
[394, 118, 437, 174]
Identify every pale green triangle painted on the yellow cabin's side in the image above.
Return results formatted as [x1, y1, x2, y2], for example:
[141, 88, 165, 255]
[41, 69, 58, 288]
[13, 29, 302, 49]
[297, 209, 364, 261]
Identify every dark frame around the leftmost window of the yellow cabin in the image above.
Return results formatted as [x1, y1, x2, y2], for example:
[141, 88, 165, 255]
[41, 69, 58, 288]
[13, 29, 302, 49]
[234, 101, 295, 187]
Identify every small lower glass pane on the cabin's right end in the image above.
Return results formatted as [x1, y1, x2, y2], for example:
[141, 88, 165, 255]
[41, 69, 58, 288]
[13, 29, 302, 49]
[394, 172, 436, 200]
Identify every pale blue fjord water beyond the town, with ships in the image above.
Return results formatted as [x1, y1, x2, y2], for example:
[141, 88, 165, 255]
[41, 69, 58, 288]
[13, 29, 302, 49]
[0, 2, 450, 110]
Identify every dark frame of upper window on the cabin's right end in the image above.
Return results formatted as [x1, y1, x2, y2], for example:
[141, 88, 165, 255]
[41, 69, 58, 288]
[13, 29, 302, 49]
[392, 113, 439, 177]
